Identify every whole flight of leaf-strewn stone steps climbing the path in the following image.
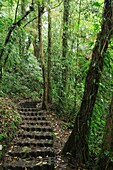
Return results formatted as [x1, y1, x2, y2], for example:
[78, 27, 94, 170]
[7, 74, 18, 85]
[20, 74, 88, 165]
[2, 102, 54, 170]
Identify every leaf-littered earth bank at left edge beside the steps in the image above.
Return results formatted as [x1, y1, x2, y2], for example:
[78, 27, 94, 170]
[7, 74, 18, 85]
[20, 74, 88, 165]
[0, 98, 21, 142]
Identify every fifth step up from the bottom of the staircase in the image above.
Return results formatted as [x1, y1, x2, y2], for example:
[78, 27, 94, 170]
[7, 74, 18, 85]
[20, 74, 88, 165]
[21, 125, 52, 133]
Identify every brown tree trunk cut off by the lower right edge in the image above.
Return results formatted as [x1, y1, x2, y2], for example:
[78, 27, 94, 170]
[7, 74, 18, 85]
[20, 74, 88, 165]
[98, 93, 113, 170]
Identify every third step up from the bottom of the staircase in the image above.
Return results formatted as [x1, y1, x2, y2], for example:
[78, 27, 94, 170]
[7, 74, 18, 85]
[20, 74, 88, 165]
[13, 137, 53, 147]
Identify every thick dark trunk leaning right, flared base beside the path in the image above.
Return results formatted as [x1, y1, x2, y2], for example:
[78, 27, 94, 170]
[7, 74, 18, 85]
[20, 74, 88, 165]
[62, 0, 113, 167]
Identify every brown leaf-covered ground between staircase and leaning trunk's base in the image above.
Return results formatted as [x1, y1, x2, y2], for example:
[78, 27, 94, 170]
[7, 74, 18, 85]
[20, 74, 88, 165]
[49, 109, 76, 170]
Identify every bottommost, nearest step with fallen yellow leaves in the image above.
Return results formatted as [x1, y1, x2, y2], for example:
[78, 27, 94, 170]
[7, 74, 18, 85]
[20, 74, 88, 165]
[3, 156, 54, 170]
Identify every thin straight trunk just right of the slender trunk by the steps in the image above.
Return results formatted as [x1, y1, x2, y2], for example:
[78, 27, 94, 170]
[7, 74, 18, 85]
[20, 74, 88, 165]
[47, 0, 52, 103]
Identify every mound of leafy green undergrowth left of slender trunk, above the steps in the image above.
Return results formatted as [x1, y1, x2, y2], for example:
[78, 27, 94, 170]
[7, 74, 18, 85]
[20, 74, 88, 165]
[0, 55, 42, 100]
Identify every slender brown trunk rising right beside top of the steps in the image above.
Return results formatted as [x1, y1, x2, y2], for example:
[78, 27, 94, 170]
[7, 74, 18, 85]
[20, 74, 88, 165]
[38, 3, 47, 109]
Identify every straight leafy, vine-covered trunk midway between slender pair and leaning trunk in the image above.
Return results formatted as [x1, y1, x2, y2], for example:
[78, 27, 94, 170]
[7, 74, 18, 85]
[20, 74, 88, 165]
[59, 0, 70, 110]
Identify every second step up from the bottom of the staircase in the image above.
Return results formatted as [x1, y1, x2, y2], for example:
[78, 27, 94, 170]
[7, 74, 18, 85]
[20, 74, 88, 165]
[7, 145, 54, 159]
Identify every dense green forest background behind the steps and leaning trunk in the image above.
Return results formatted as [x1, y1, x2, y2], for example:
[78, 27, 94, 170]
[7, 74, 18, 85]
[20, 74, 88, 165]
[0, 0, 113, 169]
